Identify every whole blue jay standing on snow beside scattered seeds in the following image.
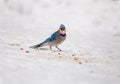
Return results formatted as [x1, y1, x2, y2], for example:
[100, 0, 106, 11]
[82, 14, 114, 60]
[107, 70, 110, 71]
[31, 24, 66, 51]
